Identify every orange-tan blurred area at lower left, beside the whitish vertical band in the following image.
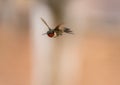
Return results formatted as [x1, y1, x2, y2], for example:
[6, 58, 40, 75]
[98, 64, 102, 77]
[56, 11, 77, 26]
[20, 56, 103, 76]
[0, 27, 30, 85]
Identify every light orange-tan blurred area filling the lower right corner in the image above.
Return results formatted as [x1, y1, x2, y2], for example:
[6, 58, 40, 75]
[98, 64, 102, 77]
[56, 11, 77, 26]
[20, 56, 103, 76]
[82, 31, 120, 85]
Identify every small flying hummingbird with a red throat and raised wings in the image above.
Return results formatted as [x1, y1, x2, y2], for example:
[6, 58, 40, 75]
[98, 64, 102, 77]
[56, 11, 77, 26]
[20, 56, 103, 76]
[41, 18, 73, 38]
